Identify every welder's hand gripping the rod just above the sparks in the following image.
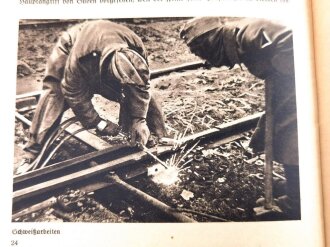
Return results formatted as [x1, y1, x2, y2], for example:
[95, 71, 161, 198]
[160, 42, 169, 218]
[131, 118, 150, 146]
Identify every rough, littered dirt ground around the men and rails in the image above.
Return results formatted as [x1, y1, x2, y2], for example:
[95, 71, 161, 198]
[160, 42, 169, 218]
[15, 18, 283, 222]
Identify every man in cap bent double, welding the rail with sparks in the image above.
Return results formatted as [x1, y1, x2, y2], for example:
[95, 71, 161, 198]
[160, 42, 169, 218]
[21, 20, 166, 174]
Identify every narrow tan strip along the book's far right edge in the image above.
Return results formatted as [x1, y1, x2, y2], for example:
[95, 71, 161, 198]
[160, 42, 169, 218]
[313, 1, 330, 245]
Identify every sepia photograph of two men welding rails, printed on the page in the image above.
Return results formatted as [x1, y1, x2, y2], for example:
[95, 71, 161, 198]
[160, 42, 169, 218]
[12, 16, 301, 223]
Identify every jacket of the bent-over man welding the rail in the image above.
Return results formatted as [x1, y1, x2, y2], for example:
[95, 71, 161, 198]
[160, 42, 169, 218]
[62, 20, 150, 128]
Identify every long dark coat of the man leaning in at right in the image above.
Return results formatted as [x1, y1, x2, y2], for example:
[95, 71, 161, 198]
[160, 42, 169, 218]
[236, 19, 299, 165]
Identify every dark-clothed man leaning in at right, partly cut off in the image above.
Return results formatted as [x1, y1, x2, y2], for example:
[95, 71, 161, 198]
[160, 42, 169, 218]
[180, 17, 300, 219]
